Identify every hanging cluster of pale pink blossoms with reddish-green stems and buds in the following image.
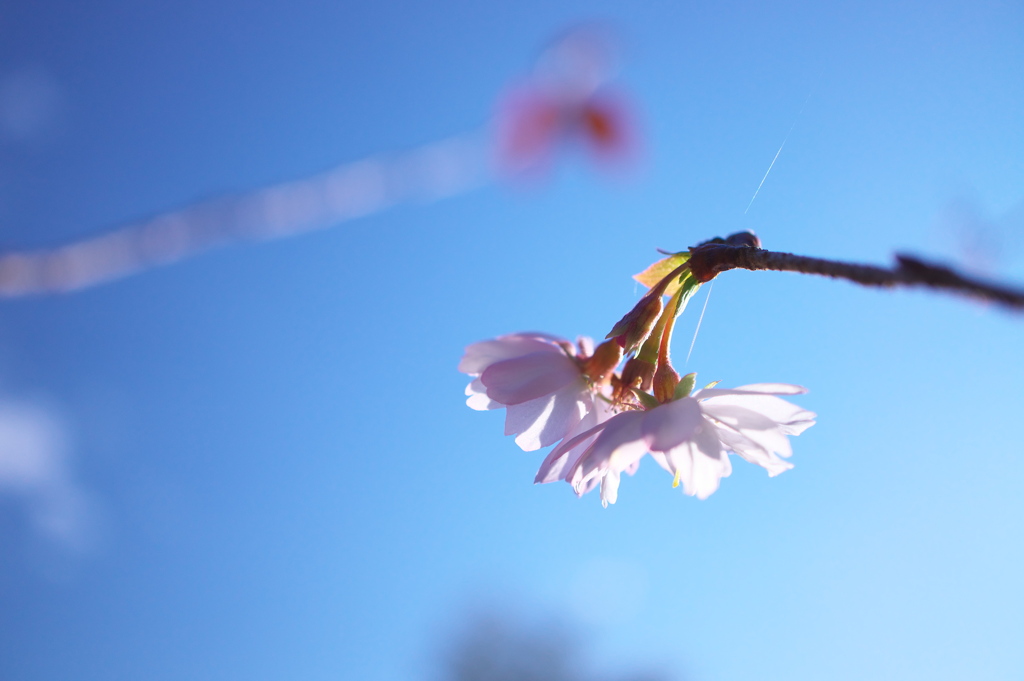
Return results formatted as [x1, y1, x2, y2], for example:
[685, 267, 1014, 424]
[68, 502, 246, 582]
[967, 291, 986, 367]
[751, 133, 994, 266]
[459, 238, 815, 506]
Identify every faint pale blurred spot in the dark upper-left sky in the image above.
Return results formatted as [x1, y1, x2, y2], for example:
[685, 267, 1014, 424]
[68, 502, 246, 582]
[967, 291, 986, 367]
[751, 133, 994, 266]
[0, 67, 63, 142]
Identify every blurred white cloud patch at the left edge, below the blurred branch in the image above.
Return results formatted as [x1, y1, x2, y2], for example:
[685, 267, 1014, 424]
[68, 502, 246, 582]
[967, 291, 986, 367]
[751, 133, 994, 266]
[0, 400, 93, 551]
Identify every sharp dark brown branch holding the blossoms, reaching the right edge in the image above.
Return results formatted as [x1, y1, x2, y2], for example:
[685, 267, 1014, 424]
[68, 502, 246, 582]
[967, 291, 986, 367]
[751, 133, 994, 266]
[689, 237, 1024, 311]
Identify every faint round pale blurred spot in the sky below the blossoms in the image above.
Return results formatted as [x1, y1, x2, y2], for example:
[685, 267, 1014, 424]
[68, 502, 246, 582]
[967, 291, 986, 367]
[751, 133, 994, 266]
[568, 558, 648, 626]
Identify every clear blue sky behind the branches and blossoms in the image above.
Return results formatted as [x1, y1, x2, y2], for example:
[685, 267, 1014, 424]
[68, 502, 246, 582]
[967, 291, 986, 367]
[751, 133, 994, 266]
[0, 0, 1024, 681]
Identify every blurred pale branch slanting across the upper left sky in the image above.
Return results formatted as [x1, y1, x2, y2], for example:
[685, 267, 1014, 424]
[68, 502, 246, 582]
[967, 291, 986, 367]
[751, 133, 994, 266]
[0, 133, 489, 298]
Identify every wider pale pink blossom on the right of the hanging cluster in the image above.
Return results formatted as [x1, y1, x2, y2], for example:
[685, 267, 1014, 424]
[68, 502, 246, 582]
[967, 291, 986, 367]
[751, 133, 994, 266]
[538, 383, 815, 506]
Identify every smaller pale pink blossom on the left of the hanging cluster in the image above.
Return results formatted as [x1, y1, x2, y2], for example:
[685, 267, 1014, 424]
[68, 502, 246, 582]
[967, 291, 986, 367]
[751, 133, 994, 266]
[459, 333, 610, 452]
